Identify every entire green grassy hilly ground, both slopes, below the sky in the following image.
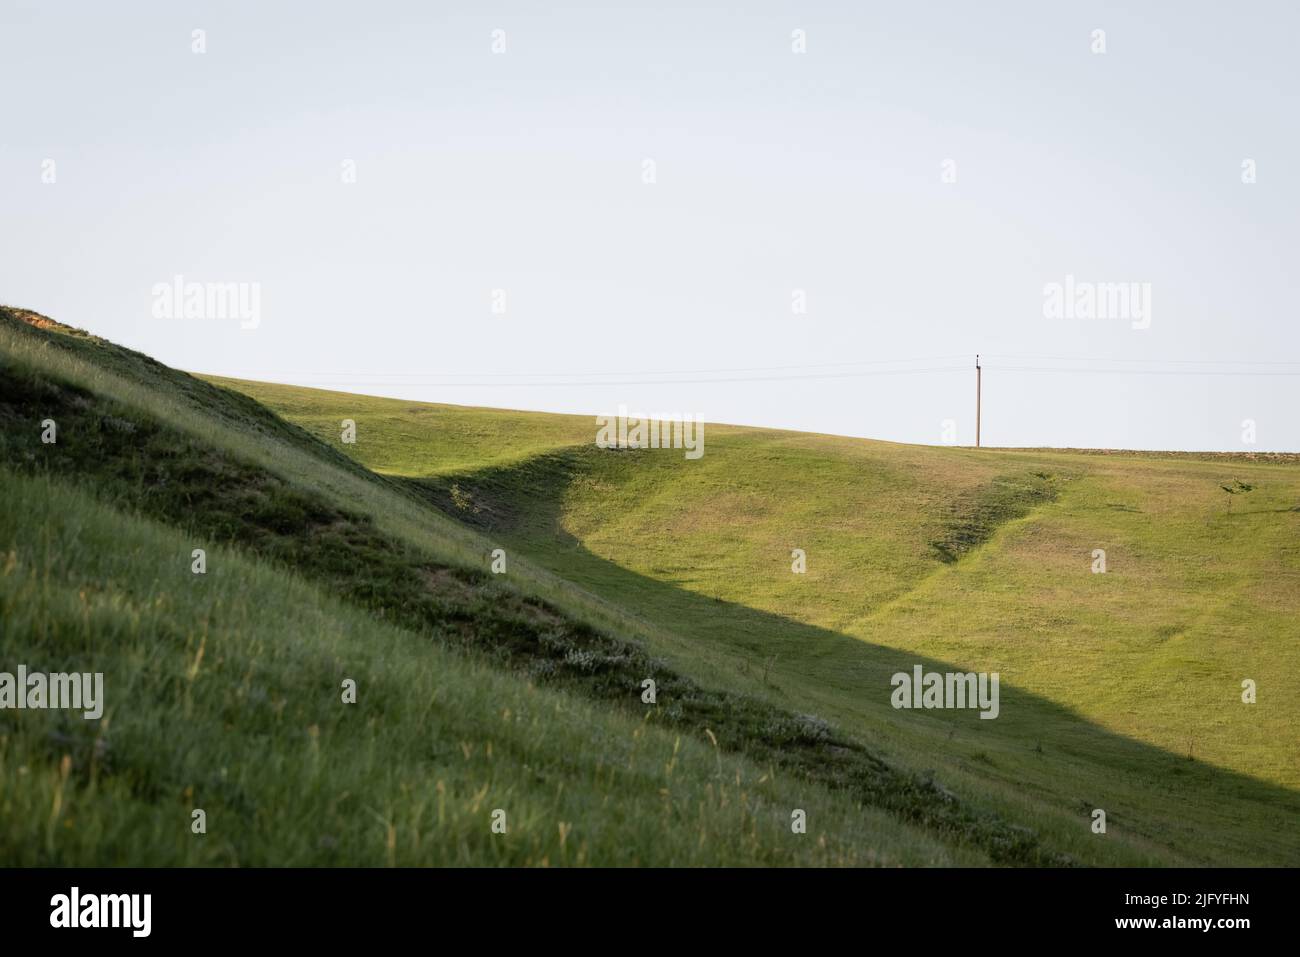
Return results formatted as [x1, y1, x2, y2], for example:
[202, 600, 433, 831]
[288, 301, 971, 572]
[0, 309, 1300, 865]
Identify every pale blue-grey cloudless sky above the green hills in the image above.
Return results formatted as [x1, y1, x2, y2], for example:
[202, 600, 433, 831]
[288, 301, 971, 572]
[0, 0, 1300, 450]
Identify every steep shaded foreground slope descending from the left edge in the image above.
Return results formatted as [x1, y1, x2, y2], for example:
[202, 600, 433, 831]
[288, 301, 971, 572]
[0, 309, 1086, 863]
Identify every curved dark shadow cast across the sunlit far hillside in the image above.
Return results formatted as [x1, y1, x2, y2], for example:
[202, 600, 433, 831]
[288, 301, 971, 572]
[402, 447, 1300, 865]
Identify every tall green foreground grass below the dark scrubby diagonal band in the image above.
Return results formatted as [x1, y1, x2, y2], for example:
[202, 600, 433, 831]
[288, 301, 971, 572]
[0, 476, 982, 866]
